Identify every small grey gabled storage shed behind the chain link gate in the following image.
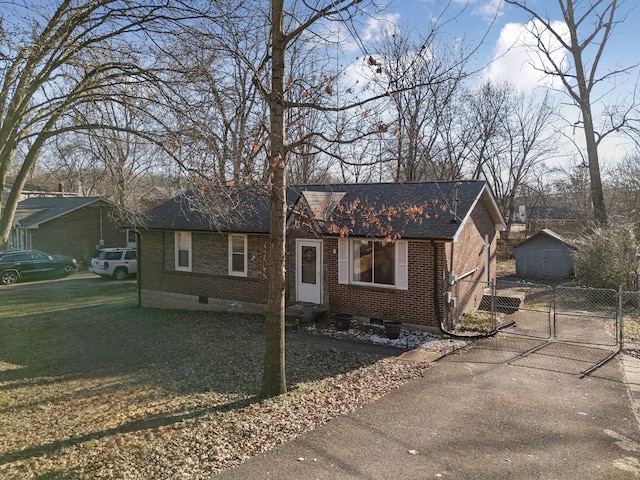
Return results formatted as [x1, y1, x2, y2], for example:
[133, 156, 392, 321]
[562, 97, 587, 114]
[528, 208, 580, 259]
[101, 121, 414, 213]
[514, 228, 576, 278]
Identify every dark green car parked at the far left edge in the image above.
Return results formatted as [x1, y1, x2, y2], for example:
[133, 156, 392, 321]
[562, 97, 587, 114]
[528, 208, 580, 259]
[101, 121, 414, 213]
[0, 250, 78, 285]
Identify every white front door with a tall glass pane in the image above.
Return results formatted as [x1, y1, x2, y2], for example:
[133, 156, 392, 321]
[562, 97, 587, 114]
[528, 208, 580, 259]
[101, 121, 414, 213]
[296, 239, 322, 303]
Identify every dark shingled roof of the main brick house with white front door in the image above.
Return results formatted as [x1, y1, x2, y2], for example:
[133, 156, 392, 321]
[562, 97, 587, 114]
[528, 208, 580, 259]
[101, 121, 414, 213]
[145, 181, 504, 240]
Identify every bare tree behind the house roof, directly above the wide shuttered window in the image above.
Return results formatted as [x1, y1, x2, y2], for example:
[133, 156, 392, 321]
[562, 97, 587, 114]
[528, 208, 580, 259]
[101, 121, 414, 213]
[362, 22, 470, 181]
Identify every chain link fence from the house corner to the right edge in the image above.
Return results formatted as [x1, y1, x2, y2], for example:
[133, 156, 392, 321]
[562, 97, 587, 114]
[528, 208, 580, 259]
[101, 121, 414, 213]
[446, 281, 640, 349]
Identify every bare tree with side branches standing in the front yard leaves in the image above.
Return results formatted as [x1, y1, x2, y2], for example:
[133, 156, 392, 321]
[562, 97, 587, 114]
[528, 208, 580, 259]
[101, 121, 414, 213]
[256, 0, 490, 395]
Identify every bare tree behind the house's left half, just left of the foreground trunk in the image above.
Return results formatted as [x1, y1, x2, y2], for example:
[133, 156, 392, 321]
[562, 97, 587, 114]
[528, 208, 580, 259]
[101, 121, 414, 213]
[160, 14, 268, 185]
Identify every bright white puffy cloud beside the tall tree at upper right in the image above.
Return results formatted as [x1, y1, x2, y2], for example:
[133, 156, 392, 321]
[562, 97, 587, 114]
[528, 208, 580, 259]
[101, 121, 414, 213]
[483, 20, 568, 91]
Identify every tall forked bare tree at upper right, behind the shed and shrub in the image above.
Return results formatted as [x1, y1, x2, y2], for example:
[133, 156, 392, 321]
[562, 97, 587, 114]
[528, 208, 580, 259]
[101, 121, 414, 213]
[505, 0, 637, 225]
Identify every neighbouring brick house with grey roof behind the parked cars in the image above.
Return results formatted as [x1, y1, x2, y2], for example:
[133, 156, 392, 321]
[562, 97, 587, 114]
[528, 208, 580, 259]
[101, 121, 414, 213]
[9, 197, 127, 262]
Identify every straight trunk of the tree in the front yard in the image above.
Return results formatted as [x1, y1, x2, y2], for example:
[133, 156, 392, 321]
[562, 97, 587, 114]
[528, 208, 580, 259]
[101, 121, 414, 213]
[262, 0, 287, 396]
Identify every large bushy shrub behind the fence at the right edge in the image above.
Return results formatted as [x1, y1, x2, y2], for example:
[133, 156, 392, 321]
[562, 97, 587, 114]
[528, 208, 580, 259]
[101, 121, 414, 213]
[575, 220, 640, 290]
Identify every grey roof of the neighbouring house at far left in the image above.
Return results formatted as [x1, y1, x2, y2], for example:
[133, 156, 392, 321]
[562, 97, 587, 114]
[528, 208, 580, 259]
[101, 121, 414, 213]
[14, 197, 112, 228]
